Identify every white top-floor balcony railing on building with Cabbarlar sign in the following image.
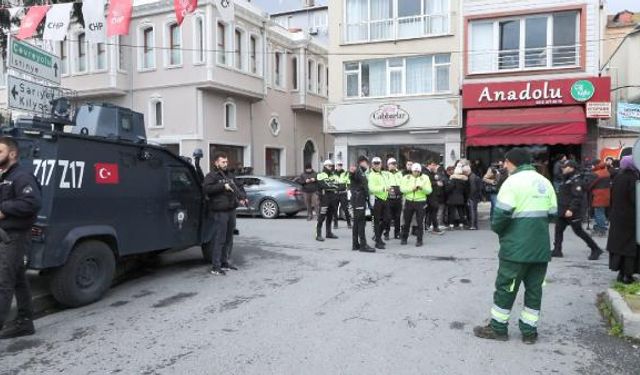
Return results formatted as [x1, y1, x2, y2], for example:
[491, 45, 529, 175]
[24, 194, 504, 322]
[341, 14, 451, 44]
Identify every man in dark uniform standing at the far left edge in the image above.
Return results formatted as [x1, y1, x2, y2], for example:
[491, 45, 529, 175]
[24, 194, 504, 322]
[0, 137, 42, 339]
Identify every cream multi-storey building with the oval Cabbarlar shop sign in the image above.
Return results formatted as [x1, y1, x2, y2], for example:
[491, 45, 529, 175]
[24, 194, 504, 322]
[324, 0, 462, 165]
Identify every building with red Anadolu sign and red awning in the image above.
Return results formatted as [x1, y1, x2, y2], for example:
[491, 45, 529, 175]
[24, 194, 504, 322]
[462, 0, 611, 165]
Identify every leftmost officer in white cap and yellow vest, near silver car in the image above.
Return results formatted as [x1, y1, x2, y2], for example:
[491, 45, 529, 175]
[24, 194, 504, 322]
[316, 160, 339, 241]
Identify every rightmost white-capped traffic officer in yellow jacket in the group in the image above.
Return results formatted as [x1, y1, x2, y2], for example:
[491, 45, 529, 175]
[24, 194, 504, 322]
[401, 163, 432, 247]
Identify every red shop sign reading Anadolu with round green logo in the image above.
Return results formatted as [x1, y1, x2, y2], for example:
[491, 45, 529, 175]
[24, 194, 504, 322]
[462, 77, 611, 109]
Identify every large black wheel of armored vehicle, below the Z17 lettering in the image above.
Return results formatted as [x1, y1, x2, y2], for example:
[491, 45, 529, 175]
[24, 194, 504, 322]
[51, 240, 116, 307]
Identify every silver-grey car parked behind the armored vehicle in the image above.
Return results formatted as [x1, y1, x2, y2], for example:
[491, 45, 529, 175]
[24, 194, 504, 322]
[236, 176, 306, 219]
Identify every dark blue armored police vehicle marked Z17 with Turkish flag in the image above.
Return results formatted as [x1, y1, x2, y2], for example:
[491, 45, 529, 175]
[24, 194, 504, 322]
[3, 103, 212, 306]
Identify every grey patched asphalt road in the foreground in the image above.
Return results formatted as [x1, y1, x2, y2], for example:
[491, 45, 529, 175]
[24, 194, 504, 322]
[0, 213, 640, 375]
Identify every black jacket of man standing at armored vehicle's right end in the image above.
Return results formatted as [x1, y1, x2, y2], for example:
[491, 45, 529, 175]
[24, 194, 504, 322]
[204, 167, 247, 211]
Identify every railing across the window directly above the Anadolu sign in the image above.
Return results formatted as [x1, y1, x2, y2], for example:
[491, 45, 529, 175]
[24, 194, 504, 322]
[469, 44, 580, 74]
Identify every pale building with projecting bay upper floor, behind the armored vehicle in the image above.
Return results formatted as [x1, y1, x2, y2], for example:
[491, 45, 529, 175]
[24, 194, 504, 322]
[0, 0, 333, 176]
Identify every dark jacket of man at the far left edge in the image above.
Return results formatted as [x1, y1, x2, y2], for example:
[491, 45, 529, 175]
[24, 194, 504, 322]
[0, 164, 42, 230]
